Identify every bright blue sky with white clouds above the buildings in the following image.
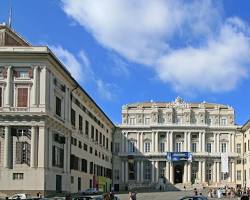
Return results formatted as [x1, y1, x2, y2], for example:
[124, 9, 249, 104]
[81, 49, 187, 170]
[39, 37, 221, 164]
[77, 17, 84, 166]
[0, 0, 250, 124]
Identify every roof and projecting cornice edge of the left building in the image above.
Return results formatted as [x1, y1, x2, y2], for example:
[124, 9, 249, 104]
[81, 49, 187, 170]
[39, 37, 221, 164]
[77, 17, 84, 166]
[0, 24, 115, 126]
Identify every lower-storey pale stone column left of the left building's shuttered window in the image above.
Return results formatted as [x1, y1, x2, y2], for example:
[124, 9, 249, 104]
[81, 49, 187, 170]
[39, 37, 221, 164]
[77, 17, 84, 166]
[4, 126, 11, 168]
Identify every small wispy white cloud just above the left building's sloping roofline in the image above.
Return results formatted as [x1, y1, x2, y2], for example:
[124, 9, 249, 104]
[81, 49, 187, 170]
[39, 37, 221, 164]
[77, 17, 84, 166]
[49, 45, 114, 100]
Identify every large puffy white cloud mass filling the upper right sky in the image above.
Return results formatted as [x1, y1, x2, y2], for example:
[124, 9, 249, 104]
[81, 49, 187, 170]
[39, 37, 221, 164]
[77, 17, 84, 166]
[61, 0, 250, 92]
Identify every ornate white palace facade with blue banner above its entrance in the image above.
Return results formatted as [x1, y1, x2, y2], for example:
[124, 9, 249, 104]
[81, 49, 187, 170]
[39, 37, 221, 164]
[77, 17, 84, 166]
[113, 97, 242, 190]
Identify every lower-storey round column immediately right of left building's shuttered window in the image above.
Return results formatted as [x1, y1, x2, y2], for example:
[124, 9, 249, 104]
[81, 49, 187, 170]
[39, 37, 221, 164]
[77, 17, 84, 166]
[30, 126, 38, 167]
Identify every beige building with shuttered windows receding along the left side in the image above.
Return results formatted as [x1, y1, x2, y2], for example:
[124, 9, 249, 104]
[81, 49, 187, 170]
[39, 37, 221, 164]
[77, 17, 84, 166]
[0, 25, 114, 196]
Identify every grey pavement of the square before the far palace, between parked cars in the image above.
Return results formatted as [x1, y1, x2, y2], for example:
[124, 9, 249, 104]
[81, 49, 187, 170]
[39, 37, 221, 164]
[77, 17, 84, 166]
[118, 191, 237, 200]
